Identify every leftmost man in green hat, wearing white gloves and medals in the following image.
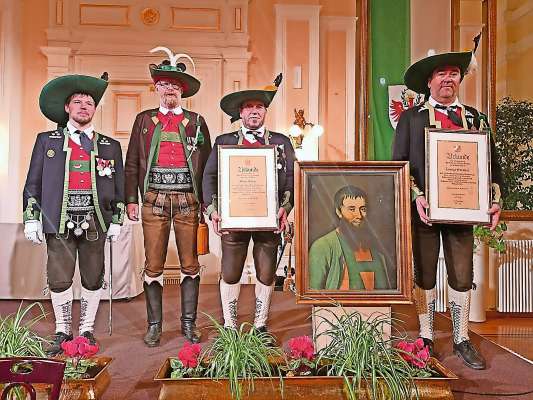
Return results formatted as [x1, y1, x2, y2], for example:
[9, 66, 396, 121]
[23, 73, 125, 354]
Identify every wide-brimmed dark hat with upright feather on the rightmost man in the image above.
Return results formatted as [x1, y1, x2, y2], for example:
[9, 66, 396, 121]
[403, 34, 481, 93]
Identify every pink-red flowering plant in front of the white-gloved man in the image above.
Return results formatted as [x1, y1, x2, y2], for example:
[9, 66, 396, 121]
[61, 336, 100, 379]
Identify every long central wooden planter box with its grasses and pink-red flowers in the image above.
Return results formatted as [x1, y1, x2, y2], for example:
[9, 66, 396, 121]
[155, 312, 456, 400]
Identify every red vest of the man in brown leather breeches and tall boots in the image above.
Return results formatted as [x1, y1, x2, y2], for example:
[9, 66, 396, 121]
[156, 112, 187, 168]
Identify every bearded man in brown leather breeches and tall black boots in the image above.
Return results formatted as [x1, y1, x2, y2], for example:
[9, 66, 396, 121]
[125, 47, 211, 347]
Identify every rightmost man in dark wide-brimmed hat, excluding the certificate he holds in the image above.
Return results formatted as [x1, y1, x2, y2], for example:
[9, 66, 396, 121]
[393, 37, 501, 369]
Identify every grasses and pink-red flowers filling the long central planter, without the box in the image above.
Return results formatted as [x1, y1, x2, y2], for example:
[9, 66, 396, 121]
[167, 309, 439, 400]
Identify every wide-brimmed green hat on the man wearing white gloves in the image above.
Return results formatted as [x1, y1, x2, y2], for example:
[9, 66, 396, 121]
[39, 72, 108, 126]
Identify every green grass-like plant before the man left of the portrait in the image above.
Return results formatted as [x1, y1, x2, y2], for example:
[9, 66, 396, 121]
[201, 315, 283, 400]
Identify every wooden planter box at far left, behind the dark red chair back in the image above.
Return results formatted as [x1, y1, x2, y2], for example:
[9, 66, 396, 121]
[34, 357, 113, 400]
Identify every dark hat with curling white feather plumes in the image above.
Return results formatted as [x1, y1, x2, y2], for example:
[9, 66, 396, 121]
[149, 46, 200, 98]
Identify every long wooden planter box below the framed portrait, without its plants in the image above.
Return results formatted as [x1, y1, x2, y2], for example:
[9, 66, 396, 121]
[154, 359, 457, 400]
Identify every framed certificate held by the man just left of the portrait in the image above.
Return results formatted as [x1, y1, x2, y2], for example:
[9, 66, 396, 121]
[218, 146, 278, 231]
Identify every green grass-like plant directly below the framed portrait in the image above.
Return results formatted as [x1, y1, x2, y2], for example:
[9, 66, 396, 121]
[317, 308, 418, 400]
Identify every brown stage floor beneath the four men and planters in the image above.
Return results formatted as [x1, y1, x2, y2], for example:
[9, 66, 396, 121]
[0, 285, 533, 400]
